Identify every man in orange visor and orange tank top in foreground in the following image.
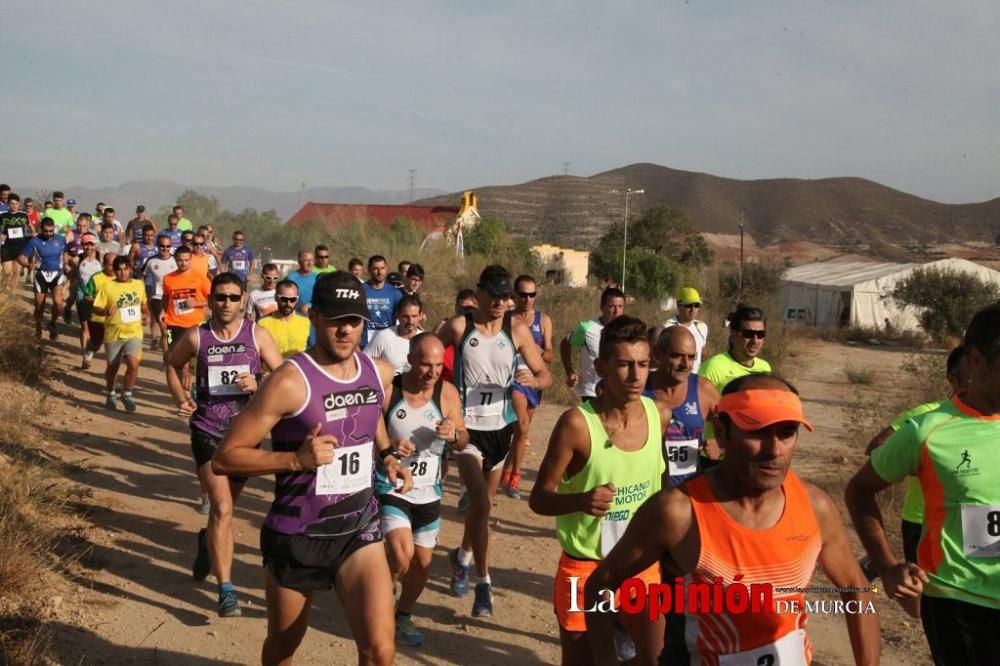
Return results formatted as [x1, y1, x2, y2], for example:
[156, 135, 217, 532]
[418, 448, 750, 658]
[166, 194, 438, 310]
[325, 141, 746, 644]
[581, 376, 880, 665]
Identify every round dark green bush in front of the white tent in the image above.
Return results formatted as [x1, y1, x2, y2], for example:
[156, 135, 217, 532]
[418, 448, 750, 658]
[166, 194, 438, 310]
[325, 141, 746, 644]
[887, 267, 1000, 340]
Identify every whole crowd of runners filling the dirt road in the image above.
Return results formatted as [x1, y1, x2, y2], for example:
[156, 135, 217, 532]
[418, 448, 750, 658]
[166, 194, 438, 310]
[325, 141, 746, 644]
[0, 185, 1000, 665]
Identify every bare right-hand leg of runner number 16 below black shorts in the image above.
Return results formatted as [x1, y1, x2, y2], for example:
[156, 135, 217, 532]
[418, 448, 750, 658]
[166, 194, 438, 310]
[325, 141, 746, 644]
[335, 543, 396, 666]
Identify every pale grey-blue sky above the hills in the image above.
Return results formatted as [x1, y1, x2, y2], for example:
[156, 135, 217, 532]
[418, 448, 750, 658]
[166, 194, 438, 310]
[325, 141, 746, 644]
[0, 0, 1000, 202]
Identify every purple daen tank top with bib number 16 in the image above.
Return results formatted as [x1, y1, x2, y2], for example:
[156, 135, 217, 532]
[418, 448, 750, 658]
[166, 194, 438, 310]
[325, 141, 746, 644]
[264, 352, 385, 537]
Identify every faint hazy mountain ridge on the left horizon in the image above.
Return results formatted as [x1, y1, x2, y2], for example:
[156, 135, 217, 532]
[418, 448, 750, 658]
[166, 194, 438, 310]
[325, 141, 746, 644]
[20, 180, 446, 220]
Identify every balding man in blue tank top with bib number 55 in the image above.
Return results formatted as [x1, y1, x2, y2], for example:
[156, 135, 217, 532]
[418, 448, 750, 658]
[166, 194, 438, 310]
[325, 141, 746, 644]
[645, 326, 719, 487]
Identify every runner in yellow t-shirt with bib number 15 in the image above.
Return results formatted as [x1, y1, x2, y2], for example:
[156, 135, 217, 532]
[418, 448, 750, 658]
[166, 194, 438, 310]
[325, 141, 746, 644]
[93, 254, 149, 412]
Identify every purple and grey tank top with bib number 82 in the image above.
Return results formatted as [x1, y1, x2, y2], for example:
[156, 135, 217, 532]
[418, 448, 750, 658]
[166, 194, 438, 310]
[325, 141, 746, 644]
[191, 319, 261, 437]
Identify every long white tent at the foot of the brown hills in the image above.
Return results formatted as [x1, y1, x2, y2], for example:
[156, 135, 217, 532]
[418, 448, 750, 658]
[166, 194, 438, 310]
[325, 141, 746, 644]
[781, 259, 1000, 330]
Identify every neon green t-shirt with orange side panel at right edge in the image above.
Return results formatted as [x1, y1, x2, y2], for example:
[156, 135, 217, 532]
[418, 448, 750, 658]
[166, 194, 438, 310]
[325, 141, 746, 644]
[871, 397, 1000, 608]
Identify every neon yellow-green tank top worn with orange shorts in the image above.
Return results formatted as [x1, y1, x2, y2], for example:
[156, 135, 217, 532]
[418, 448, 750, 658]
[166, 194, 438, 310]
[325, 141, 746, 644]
[556, 397, 665, 560]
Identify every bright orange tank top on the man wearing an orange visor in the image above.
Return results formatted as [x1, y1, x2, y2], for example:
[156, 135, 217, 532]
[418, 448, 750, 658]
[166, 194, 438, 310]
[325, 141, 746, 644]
[661, 470, 823, 666]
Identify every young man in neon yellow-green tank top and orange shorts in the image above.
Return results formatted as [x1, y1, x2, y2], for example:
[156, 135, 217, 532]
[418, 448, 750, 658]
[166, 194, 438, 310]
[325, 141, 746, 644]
[530, 316, 665, 664]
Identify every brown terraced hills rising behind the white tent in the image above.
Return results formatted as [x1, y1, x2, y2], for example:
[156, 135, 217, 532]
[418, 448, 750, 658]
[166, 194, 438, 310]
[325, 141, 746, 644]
[419, 164, 1000, 249]
